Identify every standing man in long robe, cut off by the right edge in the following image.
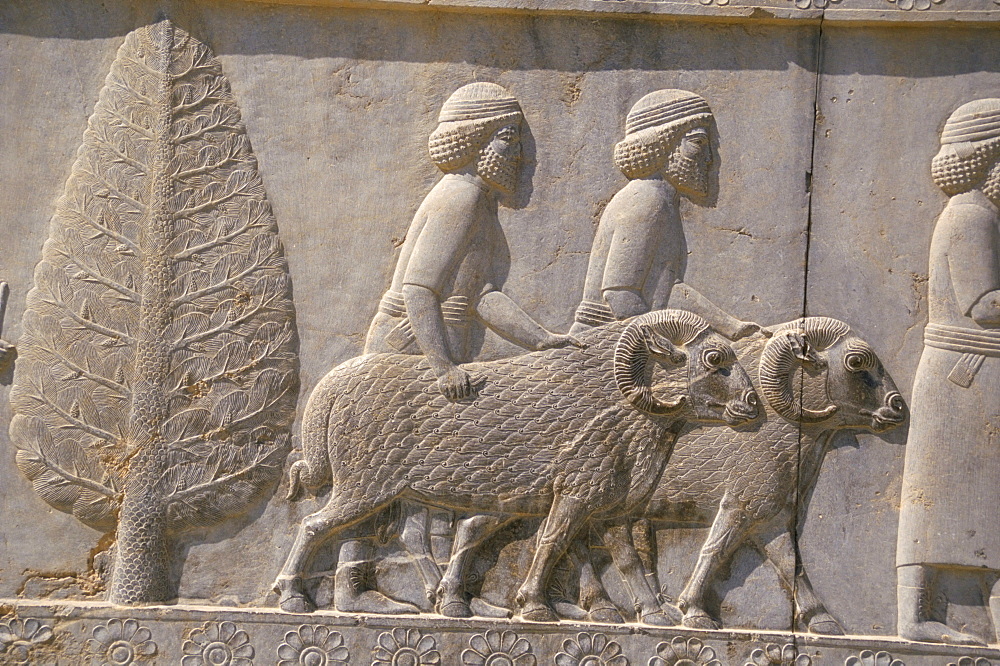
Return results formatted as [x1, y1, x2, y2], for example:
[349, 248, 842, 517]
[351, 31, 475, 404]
[896, 99, 1000, 644]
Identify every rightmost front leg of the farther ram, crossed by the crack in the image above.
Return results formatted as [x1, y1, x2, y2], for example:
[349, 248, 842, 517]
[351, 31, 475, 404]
[755, 511, 844, 636]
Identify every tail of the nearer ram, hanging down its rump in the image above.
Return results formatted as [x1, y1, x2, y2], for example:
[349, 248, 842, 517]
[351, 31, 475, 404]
[288, 375, 337, 500]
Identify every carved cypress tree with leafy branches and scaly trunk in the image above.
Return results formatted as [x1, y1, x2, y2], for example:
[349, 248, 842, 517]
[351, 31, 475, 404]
[10, 20, 298, 604]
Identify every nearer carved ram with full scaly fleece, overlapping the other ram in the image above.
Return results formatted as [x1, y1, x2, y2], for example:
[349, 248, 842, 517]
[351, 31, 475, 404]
[275, 310, 757, 621]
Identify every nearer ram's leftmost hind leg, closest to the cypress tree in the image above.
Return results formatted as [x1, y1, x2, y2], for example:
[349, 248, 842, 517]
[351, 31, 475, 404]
[274, 489, 388, 613]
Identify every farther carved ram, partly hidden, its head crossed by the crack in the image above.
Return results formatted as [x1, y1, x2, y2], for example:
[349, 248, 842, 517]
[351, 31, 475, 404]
[577, 317, 906, 634]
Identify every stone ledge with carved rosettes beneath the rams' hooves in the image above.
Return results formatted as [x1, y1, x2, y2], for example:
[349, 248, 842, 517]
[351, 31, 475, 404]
[0, 599, 1000, 666]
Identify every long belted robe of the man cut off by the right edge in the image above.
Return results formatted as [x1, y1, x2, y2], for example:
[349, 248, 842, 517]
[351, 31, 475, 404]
[896, 192, 1000, 569]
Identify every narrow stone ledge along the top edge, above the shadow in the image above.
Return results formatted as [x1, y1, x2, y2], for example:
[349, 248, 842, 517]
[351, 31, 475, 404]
[247, 0, 1000, 27]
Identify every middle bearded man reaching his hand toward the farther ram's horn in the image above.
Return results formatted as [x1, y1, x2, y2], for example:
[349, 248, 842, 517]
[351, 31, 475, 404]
[570, 90, 759, 339]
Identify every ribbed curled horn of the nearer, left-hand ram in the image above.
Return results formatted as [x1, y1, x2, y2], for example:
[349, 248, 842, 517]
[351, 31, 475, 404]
[615, 310, 708, 414]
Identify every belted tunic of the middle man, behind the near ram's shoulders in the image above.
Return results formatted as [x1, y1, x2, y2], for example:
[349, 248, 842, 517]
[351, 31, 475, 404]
[577, 180, 685, 326]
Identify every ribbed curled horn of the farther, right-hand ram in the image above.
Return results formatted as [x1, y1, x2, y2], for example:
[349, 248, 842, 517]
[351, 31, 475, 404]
[758, 317, 850, 423]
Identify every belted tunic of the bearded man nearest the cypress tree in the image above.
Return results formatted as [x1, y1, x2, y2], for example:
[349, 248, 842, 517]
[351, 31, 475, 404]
[365, 176, 508, 363]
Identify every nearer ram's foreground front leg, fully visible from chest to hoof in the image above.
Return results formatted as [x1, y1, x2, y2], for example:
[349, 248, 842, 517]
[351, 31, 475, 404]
[515, 495, 587, 622]
